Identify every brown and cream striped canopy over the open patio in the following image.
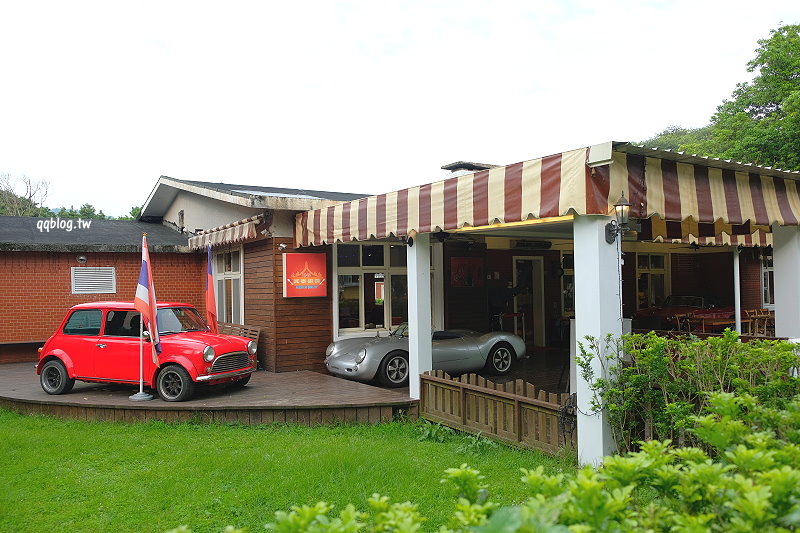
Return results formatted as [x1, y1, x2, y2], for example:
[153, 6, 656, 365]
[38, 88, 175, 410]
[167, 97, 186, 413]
[295, 143, 800, 246]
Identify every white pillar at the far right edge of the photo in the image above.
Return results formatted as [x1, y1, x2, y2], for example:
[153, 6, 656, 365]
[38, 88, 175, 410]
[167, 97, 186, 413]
[772, 224, 800, 339]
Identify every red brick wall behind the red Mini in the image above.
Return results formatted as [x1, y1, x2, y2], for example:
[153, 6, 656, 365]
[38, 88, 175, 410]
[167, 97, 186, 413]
[0, 252, 206, 344]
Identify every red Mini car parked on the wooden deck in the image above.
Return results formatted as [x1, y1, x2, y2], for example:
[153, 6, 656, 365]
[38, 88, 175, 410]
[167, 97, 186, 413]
[36, 302, 256, 402]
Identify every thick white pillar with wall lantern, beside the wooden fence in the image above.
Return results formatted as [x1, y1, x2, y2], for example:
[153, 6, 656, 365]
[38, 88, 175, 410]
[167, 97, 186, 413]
[573, 216, 622, 465]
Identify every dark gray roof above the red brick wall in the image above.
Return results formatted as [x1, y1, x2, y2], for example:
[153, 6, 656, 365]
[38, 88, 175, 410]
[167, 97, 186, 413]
[0, 217, 190, 252]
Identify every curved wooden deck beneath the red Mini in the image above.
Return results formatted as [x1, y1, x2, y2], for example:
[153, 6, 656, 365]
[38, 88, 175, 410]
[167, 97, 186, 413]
[0, 362, 418, 425]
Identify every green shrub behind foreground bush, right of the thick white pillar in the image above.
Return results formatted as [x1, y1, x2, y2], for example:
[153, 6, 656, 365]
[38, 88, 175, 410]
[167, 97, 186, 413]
[578, 330, 800, 452]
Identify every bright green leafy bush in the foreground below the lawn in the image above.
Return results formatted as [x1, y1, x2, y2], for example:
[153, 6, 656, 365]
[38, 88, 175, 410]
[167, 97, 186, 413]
[174, 393, 800, 533]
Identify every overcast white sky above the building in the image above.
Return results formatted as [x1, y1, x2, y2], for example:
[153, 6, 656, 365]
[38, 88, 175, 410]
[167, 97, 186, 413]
[0, 0, 800, 216]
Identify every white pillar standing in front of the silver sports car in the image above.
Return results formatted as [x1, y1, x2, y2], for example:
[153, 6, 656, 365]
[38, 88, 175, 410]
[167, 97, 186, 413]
[406, 233, 433, 400]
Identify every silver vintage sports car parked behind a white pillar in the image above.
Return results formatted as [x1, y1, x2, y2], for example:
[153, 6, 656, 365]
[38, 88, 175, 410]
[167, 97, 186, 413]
[325, 324, 525, 387]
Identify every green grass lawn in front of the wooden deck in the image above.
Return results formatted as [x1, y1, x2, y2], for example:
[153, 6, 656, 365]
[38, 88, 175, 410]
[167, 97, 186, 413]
[0, 410, 575, 532]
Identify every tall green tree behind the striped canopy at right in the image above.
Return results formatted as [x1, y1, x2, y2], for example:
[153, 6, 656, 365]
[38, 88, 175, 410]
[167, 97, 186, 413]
[645, 25, 800, 169]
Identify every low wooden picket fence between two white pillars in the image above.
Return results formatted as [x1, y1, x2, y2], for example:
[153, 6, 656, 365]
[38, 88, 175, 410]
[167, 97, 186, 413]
[420, 370, 577, 453]
